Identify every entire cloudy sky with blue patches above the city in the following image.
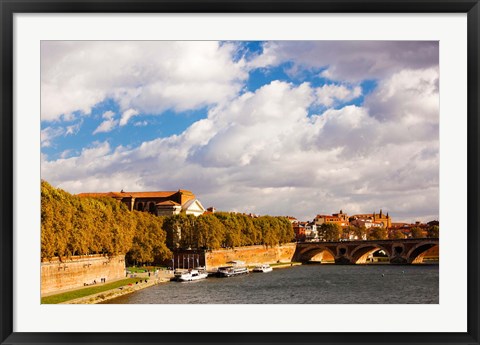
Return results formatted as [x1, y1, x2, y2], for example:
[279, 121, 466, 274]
[40, 41, 440, 222]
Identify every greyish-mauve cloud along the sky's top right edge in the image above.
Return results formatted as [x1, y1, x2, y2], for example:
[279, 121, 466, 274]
[250, 41, 438, 82]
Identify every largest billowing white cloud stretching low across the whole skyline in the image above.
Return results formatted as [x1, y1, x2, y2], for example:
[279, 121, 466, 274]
[42, 72, 439, 221]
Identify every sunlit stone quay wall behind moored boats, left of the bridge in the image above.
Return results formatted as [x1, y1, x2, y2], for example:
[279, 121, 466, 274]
[205, 243, 296, 270]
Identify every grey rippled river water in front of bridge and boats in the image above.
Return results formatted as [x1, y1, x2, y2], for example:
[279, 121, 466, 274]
[104, 265, 439, 304]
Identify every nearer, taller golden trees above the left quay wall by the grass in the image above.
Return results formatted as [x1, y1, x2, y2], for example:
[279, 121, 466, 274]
[41, 181, 171, 262]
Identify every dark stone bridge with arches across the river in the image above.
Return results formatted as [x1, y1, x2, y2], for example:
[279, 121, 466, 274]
[293, 238, 439, 264]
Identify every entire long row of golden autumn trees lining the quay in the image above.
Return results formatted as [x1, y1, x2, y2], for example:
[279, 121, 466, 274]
[41, 181, 294, 264]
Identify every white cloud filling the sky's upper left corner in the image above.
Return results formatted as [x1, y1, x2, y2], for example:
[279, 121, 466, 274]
[41, 41, 248, 121]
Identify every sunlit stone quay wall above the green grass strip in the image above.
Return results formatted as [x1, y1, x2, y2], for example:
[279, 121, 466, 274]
[41, 255, 125, 295]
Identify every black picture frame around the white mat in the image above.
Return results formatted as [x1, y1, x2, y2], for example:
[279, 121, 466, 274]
[0, 0, 480, 344]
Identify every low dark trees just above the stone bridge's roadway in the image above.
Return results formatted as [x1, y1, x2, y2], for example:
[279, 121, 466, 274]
[317, 223, 439, 241]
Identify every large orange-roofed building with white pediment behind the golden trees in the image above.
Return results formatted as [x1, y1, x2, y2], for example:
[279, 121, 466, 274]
[78, 189, 205, 216]
